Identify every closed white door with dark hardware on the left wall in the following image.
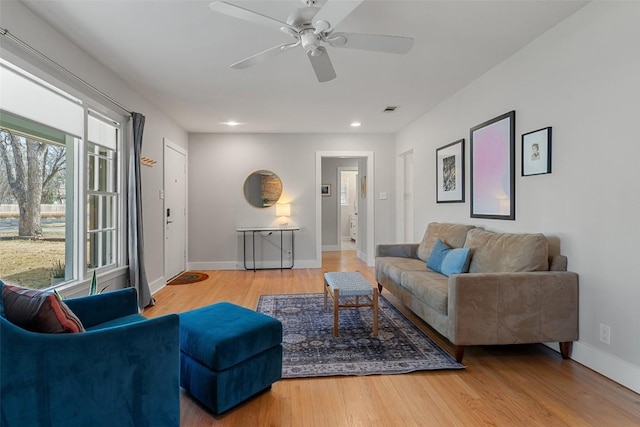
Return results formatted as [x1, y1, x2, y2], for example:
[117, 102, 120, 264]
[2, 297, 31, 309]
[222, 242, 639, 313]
[164, 140, 187, 280]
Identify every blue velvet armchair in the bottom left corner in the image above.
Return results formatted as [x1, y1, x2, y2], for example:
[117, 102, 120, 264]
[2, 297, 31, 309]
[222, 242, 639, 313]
[0, 288, 180, 427]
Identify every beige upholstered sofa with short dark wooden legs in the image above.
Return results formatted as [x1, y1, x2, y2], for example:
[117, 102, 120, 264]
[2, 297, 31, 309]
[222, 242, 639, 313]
[376, 223, 578, 361]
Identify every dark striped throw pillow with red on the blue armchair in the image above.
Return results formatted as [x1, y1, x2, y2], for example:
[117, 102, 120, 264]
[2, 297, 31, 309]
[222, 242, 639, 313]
[0, 283, 84, 333]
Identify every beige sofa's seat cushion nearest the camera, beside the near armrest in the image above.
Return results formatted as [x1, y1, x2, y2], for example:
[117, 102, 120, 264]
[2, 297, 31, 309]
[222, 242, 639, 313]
[400, 270, 449, 315]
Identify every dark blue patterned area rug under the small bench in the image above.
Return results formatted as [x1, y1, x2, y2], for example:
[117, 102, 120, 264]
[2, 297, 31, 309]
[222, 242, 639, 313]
[257, 294, 464, 378]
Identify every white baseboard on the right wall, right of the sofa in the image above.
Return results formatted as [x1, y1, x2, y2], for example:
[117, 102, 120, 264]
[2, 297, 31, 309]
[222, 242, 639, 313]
[571, 341, 640, 393]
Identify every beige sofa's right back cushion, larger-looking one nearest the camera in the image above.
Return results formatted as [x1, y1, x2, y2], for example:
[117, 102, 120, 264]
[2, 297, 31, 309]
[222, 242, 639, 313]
[464, 229, 549, 273]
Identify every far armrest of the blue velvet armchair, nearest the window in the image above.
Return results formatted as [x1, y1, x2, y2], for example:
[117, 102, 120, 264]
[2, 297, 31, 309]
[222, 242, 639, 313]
[64, 288, 138, 328]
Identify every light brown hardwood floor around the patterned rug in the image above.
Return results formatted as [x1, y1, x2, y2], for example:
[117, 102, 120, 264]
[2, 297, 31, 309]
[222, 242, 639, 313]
[144, 251, 640, 427]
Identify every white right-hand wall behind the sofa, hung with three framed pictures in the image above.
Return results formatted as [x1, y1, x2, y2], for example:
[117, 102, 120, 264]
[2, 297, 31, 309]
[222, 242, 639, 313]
[396, 2, 640, 391]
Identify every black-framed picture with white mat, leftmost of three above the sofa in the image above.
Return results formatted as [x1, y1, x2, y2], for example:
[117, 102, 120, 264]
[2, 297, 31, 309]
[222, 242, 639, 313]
[436, 139, 464, 203]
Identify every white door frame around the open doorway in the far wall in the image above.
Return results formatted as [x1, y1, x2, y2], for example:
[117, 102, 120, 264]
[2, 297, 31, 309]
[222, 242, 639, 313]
[315, 151, 375, 268]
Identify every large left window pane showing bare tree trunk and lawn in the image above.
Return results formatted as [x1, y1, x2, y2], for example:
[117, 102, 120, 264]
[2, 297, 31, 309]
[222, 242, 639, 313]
[0, 111, 78, 289]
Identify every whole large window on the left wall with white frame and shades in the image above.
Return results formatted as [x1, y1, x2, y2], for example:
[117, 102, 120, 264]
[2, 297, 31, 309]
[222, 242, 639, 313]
[0, 59, 124, 289]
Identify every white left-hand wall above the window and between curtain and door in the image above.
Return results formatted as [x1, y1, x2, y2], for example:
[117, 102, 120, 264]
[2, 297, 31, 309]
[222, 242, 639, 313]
[0, 1, 188, 298]
